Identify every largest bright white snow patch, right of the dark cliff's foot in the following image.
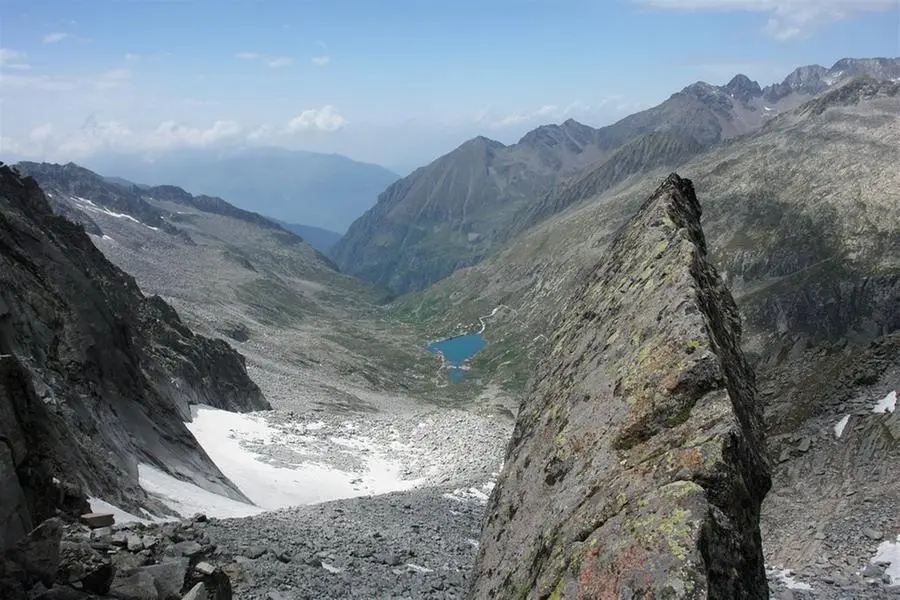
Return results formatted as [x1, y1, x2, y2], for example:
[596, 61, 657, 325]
[185, 405, 420, 514]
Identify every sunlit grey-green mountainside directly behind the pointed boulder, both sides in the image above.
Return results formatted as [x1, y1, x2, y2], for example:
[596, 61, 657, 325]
[394, 79, 900, 410]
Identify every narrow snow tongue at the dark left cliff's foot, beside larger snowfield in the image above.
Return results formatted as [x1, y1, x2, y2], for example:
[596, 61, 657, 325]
[138, 463, 263, 518]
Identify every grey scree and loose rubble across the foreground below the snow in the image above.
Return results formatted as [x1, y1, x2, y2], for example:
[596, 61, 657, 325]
[0, 488, 900, 600]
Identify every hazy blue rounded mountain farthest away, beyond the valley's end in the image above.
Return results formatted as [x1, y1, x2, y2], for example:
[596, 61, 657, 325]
[86, 148, 399, 232]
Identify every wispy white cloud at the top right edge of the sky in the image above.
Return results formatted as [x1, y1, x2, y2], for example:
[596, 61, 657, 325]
[632, 0, 897, 41]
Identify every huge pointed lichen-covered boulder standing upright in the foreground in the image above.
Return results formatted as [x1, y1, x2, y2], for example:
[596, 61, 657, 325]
[472, 174, 770, 599]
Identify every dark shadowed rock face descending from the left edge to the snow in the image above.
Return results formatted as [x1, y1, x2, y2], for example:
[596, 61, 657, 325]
[0, 165, 269, 536]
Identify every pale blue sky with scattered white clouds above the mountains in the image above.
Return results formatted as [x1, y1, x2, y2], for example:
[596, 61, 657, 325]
[0, 0, 900, 170]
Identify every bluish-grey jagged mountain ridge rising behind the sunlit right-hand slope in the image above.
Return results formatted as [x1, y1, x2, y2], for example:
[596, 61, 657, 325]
[330, 58, 900, 293]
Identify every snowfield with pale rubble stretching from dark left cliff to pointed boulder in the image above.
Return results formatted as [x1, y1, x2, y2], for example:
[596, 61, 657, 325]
[132, 405, 506, 520]
